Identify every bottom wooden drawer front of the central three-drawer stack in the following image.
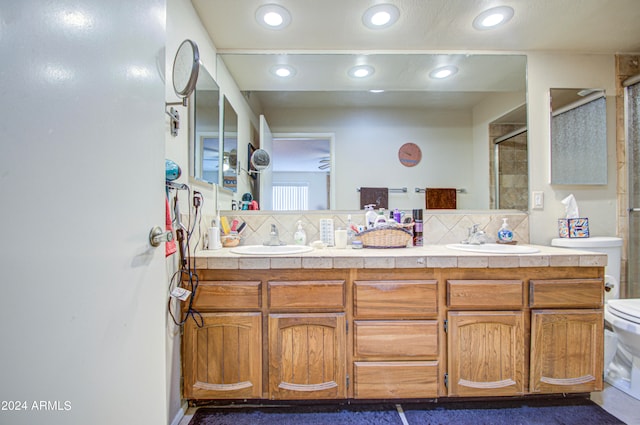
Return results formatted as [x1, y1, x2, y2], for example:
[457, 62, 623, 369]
[353, 361, 438, 398]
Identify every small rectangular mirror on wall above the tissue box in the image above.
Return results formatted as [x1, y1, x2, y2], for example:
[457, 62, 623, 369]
[550, 88, 607, 185]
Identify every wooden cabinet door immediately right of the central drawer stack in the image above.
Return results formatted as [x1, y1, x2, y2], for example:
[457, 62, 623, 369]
[447, 311, 524, 396]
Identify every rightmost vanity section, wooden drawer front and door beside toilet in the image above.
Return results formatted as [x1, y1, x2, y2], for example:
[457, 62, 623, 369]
[529, 279, 604, 393]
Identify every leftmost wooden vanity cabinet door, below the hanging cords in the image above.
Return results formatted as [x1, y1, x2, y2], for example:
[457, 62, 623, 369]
[183, 313, 262, 399]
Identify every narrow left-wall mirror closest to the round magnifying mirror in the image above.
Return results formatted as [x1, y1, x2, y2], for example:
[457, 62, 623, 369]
[189, 65, 220, 183]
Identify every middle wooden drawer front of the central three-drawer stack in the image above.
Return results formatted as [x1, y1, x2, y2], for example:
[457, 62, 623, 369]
[354, 320, 438, 360]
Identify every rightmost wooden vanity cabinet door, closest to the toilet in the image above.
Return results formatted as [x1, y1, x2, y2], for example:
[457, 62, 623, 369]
[529, 310, 604, 393]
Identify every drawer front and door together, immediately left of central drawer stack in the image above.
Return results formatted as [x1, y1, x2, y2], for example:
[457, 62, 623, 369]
[267, 280, 347, 400]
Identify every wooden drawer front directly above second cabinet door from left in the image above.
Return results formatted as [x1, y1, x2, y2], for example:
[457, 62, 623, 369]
[269, 280, 345, 310]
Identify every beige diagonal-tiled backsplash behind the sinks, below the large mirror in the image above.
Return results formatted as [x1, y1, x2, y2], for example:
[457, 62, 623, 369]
[203, 210, 529, 245]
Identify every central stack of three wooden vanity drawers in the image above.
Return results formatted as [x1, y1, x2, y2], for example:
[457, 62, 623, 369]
[353, 278, 439, 399]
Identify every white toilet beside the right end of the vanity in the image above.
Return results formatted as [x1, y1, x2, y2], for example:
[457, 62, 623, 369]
[551, 237, 640, 400]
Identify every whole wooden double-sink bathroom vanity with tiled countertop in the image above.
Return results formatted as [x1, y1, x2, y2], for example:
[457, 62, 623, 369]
[182, 246, 606, 400]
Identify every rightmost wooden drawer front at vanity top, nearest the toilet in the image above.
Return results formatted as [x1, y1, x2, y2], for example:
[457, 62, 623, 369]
[529, 279, 604, 308]
